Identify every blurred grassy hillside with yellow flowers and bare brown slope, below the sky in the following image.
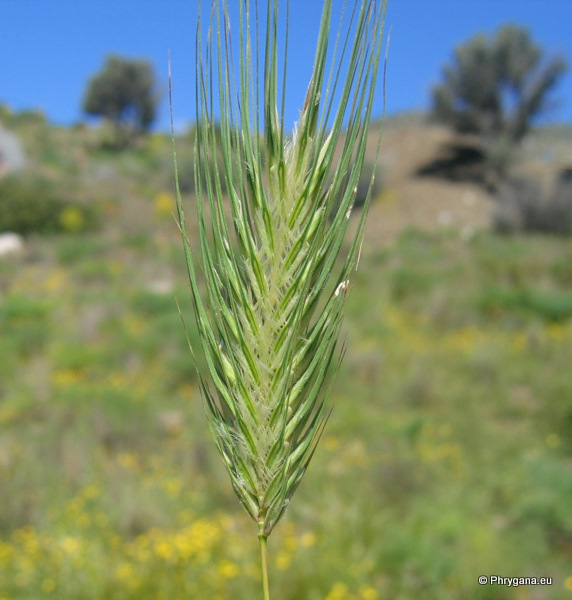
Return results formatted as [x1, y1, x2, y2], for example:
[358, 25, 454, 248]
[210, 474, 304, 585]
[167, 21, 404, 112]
[0, 108, 572, 600]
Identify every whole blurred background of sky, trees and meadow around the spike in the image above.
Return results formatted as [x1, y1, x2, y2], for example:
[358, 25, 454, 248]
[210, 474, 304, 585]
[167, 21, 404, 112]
[0, 0, 572, 600]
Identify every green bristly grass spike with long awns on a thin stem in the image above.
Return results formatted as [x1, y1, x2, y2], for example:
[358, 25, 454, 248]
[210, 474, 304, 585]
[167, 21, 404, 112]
[170, 0, 385, 600]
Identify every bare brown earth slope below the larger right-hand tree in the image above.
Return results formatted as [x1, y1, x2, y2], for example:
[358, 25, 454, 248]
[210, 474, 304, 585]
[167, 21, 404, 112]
[369, 114, 572, 244]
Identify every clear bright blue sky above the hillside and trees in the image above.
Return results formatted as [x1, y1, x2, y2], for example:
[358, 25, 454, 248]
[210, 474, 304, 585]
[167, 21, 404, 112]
[0, 0, 572, 128]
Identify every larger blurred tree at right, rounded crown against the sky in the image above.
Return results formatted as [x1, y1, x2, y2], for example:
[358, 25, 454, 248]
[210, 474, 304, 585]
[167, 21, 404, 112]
[432, 25, 567, 175]
